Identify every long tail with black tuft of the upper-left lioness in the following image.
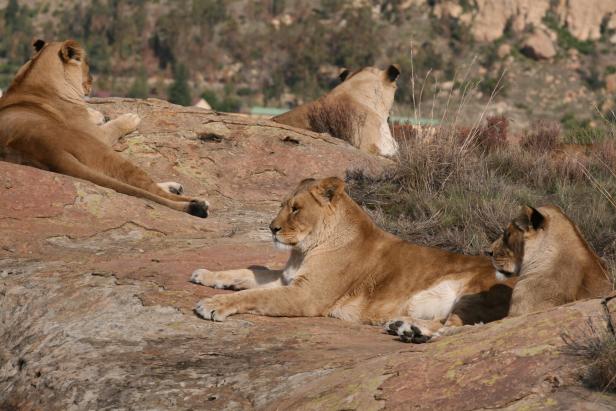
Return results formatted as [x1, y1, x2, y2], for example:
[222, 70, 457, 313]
[51, 152, 207, 218]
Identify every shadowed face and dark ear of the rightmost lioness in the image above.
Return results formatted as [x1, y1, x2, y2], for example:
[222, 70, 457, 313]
[490, 206, 546, 277]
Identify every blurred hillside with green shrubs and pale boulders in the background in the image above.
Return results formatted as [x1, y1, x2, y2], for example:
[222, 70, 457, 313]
[0, 0, 616, 129]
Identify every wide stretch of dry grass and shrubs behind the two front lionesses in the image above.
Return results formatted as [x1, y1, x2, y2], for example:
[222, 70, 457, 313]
[347, 117, 616, 286]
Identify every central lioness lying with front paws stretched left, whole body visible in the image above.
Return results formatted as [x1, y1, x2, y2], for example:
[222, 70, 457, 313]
[191, 177, 515, 342]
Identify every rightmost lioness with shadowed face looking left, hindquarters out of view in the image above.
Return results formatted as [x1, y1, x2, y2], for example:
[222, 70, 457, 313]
[492, 205, 612, 316]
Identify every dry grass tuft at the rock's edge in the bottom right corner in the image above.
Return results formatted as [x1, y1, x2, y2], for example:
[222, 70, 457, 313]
[562, 308, 616, 393]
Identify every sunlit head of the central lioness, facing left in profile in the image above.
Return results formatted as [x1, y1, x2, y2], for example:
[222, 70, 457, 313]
[270, 177, 345, 250]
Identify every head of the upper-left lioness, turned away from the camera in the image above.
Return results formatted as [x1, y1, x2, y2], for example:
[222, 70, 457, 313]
[9, 40, 92, 97]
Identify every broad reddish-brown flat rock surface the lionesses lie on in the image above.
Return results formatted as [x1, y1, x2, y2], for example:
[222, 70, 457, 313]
[0, 99, 616, 410]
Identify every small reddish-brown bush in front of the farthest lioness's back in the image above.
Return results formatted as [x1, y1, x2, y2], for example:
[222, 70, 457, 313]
[308, 103, 366, 146]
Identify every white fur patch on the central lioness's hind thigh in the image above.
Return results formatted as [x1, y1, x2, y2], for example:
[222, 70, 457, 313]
[408, 280, 464, 320]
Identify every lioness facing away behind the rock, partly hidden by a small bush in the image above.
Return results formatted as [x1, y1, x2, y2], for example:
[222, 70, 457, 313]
[272, 65, 400, 156]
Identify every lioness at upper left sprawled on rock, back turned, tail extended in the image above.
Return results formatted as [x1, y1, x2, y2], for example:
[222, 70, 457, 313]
[0, 40, 208, 217]
